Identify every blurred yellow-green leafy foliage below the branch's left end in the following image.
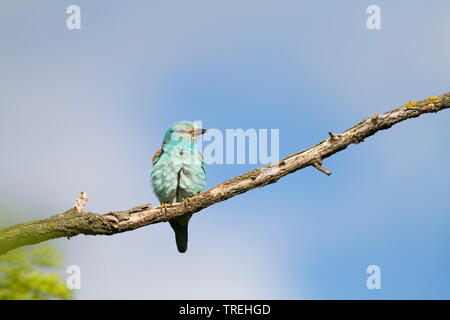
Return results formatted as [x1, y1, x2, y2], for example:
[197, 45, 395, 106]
[0, 245, 73, 300]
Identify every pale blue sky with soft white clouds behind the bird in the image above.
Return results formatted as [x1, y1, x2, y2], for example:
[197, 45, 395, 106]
[0, 0, 450, 299]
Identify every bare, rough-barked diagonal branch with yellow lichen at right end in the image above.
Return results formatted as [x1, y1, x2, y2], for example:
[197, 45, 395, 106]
[0, 92, 450, 254]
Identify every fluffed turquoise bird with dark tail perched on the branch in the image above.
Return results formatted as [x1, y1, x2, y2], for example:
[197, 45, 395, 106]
[150, 121, 206, 253]
